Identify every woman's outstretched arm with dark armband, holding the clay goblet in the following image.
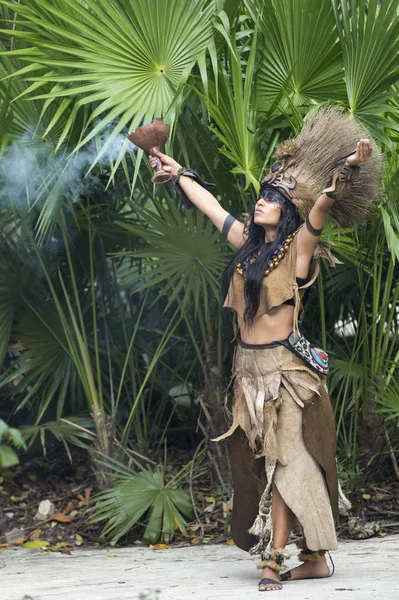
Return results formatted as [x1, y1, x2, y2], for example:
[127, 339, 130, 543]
[149, 151, 245, 248]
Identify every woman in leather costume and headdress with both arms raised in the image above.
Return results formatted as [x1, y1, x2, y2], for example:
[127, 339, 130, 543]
[150, 109, 379, 591]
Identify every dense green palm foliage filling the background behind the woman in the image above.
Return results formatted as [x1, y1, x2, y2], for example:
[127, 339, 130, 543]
[0, 0, 399, 520]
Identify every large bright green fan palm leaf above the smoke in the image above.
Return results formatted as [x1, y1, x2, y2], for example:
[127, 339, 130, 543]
[2, 0, 214, 160]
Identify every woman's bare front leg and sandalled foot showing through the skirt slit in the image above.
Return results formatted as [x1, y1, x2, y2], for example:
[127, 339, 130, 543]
[259, 485, 295, 592]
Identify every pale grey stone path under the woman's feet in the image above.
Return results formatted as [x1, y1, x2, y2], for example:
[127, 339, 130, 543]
[0, 535, 399, 600]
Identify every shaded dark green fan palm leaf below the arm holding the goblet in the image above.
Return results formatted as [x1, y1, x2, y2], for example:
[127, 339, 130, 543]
[117, 202, 227, 315]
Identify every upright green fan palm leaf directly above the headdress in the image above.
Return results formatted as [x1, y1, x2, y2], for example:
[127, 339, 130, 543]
[246, 0, 345, 108]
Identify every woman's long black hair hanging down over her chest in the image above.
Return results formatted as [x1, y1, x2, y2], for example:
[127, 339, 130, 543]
[222, 186, 301, 327]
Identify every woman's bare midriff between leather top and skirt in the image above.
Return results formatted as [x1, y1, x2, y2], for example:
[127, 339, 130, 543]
[237, 304, 294, 344]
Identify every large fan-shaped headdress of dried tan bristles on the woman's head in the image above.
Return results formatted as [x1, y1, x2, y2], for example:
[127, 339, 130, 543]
[261, 106, 382, 226]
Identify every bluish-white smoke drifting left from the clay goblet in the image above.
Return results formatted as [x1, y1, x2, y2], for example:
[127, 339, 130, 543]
[0, 126, 136, 211]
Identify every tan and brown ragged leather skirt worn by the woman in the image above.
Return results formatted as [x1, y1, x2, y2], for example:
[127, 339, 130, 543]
[215, 342, 338, 560]
